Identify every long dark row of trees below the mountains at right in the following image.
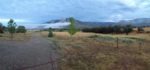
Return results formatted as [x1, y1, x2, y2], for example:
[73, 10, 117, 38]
[82, 25, 133, 35]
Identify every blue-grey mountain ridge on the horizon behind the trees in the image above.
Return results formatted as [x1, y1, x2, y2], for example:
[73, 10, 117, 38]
[46, 18, 150, 29]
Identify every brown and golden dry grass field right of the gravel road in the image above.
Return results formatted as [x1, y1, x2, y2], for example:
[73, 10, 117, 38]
[42, 32, 150, 70]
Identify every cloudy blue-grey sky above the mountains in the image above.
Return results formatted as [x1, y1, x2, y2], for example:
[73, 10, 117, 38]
[0, 0, 150, 28]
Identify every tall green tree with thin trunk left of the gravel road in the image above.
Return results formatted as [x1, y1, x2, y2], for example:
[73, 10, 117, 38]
[8, 19, 17, 39]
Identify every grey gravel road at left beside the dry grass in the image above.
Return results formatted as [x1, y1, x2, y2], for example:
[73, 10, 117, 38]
[0, 34, 57, 70]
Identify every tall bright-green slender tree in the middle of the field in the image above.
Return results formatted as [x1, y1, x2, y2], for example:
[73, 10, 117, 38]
[69, 17, 77, 36]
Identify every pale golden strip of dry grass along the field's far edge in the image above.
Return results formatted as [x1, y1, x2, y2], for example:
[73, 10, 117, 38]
[41, 31, 150, 40]
